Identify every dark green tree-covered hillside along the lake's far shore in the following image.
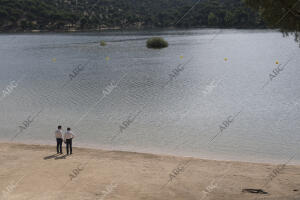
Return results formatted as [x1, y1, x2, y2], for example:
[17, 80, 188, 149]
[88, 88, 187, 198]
[0, 0, 264, 31]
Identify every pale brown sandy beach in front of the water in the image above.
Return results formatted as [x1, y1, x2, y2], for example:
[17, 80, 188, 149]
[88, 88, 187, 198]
[0, 143, 300, 200]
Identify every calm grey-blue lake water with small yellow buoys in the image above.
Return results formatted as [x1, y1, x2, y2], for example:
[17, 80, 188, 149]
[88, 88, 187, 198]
[0, 29, 300, 163]
